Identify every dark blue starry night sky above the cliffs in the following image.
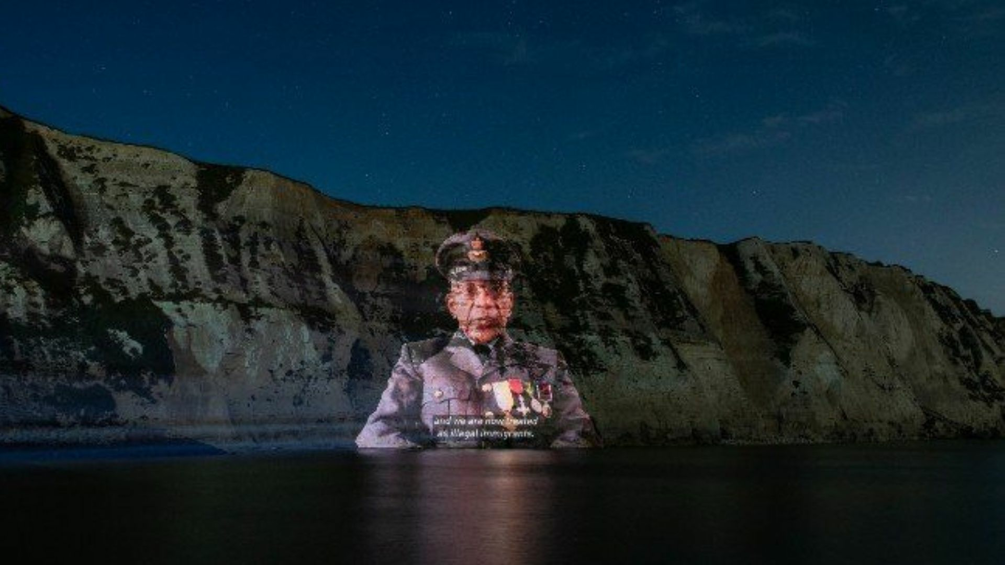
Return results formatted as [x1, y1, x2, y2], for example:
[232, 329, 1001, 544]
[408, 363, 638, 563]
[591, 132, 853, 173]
[0, 0, 1005, 315]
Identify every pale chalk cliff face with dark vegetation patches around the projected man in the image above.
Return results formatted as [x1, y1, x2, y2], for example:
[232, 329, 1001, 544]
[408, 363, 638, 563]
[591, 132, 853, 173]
[0, 106, 1005, 444]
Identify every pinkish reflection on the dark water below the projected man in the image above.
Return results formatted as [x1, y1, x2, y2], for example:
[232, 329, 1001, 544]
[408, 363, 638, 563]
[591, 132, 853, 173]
[362, 450, 557, 563]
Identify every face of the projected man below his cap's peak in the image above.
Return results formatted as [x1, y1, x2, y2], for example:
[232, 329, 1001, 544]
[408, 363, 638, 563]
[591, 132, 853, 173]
[446, 280, 514, 344]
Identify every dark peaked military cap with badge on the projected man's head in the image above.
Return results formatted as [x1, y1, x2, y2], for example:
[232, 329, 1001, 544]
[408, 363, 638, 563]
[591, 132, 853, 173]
[436, 228, 520, 281]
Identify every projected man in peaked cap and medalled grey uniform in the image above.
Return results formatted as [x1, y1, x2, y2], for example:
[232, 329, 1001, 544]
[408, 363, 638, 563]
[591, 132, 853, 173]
[356, 229, 600, 447]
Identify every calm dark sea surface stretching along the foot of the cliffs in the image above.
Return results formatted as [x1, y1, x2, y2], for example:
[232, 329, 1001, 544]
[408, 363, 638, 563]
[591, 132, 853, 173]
[0, 441, 1005, 565]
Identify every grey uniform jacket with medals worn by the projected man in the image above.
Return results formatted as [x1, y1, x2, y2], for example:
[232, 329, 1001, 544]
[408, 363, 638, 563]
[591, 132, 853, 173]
[356, 330, 600, 447]
